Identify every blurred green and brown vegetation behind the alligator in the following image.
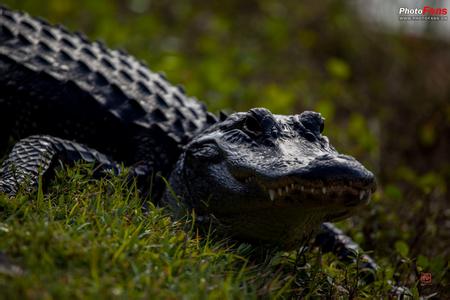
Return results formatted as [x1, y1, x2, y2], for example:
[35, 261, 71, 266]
[2, 0, 450, 296]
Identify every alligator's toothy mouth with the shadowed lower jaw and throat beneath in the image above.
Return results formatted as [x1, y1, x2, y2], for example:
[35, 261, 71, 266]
[207, 175, 375, 248]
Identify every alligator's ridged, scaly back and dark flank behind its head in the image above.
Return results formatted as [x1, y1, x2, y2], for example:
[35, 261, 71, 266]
[0, 7, 214, 163]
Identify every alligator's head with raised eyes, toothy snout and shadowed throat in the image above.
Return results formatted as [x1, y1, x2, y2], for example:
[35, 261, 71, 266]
[163, 108, 375, 248]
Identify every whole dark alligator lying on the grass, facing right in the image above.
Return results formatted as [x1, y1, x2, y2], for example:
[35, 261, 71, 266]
[0, 7, 390, 284]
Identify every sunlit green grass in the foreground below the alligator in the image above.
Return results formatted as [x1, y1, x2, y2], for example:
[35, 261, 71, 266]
[0, 166, 410, 299]
